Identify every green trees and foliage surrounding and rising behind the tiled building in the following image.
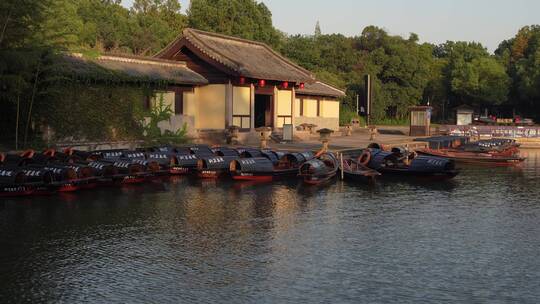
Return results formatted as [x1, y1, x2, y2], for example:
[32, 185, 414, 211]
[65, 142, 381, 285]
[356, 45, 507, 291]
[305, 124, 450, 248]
[0, 0, 540, 146]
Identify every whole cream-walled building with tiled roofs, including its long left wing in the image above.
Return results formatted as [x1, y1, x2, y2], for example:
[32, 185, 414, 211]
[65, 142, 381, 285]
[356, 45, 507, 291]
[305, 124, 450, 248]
[64, 29, 345, 142]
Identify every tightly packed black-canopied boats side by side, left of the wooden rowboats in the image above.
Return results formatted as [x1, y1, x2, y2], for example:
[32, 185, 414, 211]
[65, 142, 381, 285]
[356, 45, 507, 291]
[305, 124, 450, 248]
[0, 145, 314, 196]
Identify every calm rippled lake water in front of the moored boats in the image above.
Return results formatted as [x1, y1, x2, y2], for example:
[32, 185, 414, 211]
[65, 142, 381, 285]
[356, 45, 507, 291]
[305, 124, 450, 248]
[0, 151, 540, 303]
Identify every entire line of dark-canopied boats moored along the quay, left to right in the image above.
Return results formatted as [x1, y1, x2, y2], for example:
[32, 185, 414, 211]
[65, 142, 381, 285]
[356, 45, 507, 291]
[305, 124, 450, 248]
[4, 137, 523, 196]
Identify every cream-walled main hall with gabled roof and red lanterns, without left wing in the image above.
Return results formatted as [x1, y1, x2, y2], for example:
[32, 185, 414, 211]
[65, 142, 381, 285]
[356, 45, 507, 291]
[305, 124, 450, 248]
[151, 29, 345, 135]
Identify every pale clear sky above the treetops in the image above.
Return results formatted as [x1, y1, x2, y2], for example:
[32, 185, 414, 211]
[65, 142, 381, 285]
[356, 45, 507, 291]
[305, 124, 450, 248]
[123, 0, 540, 51]
